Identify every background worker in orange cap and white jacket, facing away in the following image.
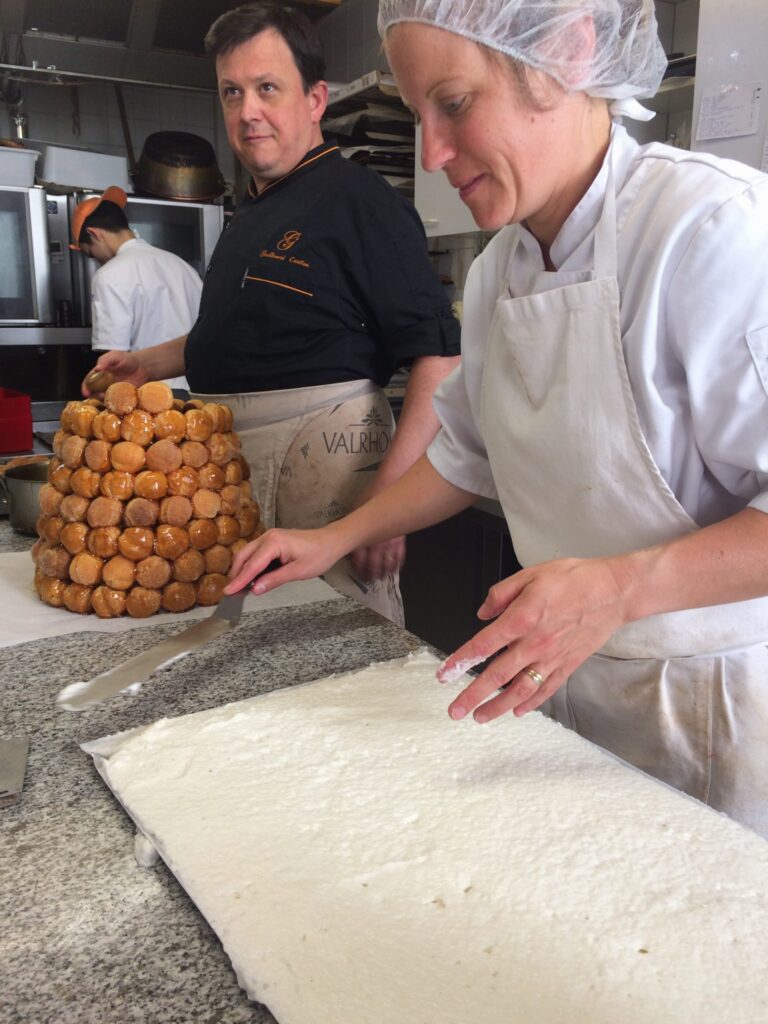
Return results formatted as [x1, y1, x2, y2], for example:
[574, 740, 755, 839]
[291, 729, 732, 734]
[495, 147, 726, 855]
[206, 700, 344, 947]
[70, 185, 203, 389]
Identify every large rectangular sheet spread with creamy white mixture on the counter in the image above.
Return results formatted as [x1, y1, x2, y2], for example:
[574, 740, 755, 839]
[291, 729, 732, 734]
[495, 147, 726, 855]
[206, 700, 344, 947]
[86, 652, 768, 1024]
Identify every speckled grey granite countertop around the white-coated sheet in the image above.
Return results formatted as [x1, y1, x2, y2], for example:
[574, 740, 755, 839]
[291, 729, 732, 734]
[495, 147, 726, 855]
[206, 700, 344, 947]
[0, 519, 423, 1024]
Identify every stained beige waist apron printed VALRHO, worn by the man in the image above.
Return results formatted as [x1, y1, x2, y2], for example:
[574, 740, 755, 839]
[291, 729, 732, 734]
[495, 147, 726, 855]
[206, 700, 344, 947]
[196, 380, 403, 626]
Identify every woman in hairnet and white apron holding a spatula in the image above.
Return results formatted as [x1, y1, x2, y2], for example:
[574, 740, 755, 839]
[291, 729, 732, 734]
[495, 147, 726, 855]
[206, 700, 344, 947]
[229, 0, 768, 836]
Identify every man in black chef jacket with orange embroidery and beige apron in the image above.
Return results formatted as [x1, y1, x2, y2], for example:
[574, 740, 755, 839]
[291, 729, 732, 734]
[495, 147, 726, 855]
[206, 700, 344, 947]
[85, 2, 459, 623]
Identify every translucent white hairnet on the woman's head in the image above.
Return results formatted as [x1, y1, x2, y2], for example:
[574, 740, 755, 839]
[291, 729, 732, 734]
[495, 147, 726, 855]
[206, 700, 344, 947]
[379, 0, 667, 99]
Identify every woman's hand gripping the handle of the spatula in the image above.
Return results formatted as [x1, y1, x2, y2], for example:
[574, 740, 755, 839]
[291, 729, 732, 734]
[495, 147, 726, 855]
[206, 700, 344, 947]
[224, 526, 345, 594]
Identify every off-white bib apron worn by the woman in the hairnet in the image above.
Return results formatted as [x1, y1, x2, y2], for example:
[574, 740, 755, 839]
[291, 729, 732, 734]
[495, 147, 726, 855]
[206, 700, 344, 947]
[480, 157, 768, 838]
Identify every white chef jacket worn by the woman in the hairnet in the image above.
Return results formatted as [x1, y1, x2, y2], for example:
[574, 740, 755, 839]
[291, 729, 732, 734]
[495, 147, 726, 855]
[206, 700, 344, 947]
[428, 125, 768, 526]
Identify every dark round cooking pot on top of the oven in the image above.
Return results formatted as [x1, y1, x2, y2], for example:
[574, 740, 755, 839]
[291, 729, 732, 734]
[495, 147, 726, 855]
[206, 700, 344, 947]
[133, 131, 225, 203]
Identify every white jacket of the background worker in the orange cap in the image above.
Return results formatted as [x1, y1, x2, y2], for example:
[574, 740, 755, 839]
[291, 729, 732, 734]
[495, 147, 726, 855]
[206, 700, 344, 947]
[91, 239, 203, 388]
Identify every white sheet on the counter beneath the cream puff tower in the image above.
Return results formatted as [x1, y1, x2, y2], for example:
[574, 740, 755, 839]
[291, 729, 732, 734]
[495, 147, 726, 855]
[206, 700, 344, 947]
[0, 551, 341, 648]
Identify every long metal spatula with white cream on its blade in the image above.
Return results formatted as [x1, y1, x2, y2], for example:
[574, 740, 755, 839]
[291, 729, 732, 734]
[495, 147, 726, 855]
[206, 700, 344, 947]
[56, 559, 282, 711]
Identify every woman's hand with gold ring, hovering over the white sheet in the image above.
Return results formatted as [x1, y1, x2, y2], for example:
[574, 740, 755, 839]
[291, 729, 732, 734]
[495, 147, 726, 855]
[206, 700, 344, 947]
[437, 558, 628, 722]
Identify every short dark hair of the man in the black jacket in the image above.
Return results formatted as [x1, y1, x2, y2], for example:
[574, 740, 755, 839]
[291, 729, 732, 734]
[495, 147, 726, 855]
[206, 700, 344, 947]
[205, 0, 326, 92]
